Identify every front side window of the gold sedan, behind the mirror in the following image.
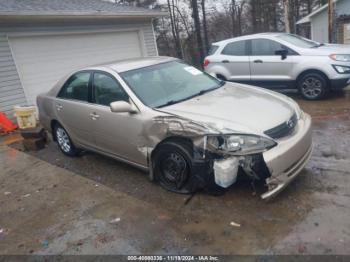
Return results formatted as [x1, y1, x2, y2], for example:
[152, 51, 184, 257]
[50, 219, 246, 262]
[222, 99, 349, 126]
[93, 73, 129, 106]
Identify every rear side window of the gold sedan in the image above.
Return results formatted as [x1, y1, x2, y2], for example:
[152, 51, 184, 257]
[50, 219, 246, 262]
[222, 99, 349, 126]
[58, 72, 90, 102]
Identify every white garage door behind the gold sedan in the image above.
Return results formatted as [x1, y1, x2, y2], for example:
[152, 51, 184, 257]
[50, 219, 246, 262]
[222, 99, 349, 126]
[9, 31, 142, 105]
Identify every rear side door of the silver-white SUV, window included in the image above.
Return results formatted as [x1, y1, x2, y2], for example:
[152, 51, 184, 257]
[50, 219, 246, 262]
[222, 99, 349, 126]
[220, 41, 250, 82]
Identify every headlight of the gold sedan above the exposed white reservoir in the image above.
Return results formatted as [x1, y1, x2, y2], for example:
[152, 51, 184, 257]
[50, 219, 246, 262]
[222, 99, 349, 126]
[207, 134, 277, 156]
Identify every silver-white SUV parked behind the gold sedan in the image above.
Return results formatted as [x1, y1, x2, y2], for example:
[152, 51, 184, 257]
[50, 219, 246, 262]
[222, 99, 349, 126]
[204, 33, 350, 100]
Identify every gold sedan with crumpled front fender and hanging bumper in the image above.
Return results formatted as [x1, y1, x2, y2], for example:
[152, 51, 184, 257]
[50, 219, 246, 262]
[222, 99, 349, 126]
[37, 57, 312, 199]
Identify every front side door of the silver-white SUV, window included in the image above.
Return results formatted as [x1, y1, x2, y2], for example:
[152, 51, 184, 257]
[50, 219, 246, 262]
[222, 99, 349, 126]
[249, 39, 294, 89]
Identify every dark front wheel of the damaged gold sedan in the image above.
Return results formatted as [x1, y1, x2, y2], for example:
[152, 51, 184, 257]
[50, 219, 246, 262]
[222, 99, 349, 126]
[153, 141, 195, 194]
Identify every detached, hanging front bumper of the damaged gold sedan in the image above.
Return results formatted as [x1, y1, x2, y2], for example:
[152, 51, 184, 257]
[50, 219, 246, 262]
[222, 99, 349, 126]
[261, 113, 312, 199]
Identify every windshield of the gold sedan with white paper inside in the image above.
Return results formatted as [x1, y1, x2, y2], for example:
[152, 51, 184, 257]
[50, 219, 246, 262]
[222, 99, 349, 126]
[120, 61, 222, 107]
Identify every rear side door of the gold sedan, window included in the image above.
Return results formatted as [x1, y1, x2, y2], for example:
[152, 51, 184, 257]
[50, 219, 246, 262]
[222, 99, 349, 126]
[54, 71, 94, 147]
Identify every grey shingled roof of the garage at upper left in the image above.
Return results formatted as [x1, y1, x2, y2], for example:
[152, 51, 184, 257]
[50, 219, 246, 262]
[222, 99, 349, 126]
[0, 0, 167, 17]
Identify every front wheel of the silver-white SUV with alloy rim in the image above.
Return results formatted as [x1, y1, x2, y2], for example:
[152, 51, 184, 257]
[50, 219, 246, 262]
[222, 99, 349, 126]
[297, 72, 329, 100]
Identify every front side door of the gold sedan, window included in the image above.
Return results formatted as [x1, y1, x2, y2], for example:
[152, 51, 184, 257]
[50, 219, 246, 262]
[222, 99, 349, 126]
[91, 71, 147, 166]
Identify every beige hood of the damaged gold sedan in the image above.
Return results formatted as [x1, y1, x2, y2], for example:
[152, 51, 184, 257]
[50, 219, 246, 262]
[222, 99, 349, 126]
[159, 83, 295, 135]
